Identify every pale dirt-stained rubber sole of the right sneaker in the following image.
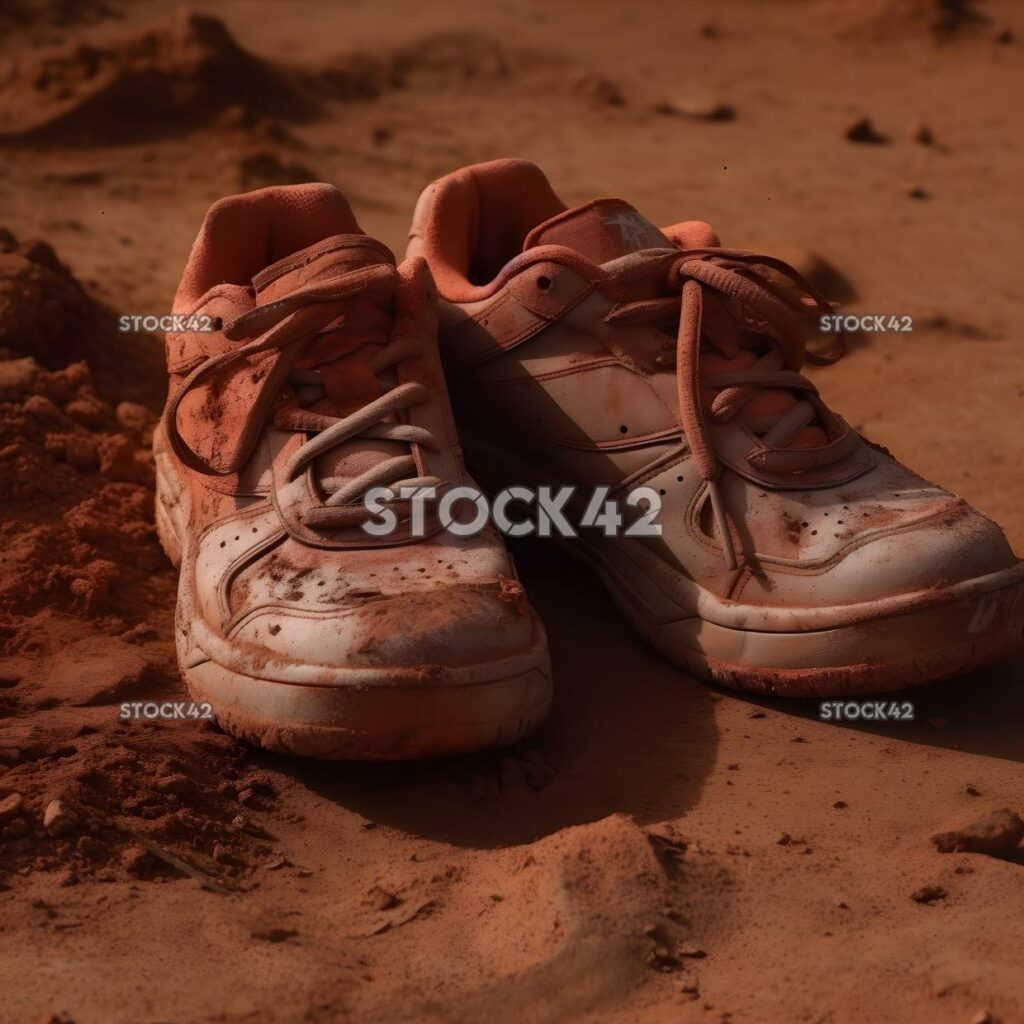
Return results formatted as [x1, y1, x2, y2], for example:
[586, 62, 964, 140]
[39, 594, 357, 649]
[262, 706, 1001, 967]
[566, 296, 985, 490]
[559, 541, 1024, 697]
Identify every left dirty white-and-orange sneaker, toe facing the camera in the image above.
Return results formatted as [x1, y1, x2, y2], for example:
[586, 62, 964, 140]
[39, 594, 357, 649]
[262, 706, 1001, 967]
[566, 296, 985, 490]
[155, 184, 551, 759]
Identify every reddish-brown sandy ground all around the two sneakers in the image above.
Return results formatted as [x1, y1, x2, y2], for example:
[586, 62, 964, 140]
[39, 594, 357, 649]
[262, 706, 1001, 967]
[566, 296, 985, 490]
[0, 0, 1024, 1024]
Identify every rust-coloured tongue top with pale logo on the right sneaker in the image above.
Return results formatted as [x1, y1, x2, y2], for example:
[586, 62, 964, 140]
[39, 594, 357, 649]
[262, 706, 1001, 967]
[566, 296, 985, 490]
[522, 199, 673, 263]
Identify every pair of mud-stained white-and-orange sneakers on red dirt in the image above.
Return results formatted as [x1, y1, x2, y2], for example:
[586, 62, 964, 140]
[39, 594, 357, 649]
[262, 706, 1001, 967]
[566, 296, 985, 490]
[155, 160, 1024, 759]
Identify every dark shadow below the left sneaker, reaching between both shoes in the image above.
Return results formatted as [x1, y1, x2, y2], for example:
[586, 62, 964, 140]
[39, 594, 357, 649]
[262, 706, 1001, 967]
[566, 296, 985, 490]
[273, 542, 718, 848]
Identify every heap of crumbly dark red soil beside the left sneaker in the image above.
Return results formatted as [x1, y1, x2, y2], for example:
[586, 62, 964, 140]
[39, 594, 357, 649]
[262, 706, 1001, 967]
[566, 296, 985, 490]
[0, 237, 218, 897]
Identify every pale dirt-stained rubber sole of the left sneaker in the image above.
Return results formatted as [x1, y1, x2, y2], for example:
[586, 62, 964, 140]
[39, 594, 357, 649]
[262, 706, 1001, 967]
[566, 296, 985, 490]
[156, 448, 552, 761]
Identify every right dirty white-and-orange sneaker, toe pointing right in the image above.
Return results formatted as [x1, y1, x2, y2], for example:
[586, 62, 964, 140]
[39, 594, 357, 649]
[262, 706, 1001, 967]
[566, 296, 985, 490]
[409, 160, 1024, 695]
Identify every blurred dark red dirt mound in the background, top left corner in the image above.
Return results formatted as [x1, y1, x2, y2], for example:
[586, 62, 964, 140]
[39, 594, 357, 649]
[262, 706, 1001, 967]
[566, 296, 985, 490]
[0, 11, 311, 144]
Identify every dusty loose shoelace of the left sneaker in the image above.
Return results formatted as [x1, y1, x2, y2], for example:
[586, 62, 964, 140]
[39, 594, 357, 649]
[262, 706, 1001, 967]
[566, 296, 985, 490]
[165, 264, 442, 529]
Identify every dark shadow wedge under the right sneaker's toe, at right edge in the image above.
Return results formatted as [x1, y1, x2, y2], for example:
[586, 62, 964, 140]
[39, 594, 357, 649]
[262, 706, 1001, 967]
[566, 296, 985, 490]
[752, 655, 1024, 763]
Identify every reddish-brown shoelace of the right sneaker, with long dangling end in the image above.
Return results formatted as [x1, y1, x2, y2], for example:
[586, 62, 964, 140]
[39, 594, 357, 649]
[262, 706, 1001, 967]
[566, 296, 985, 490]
[606, 248, 857, 569]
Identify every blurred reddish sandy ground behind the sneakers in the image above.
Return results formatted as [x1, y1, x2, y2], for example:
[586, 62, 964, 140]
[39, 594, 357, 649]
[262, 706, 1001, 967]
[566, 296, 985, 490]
[0, 0, 1024, 546]
